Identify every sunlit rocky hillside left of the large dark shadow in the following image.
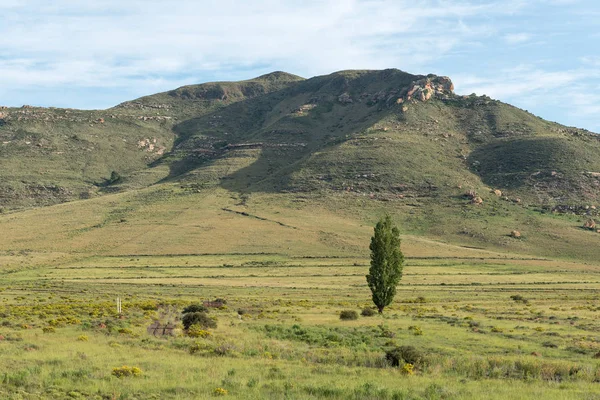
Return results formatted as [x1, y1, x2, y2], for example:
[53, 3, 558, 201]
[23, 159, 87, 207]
[0, 72, 302, 209]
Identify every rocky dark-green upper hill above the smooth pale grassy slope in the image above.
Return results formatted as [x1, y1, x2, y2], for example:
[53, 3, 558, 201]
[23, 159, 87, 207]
[0, 69, 600, 210]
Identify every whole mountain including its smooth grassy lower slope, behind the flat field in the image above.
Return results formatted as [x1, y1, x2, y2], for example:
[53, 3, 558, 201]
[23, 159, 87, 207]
[0, 69, 600, 262]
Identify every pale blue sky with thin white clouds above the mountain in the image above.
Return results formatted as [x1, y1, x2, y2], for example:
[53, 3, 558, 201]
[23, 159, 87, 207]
[0, 0, 600, 132]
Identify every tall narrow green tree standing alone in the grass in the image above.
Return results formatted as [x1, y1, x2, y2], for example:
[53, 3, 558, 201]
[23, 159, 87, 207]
[367, 215, 404, 314]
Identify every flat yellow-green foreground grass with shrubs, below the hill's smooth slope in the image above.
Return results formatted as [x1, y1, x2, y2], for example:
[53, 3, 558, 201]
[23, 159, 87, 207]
[0, 250, 600, 399]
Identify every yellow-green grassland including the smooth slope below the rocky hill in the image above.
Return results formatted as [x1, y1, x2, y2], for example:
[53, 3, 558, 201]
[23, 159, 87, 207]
[0, 184, 600, 399]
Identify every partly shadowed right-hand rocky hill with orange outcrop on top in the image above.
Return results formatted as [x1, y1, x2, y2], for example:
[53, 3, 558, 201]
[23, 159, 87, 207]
[157, 70, 600, 205]
